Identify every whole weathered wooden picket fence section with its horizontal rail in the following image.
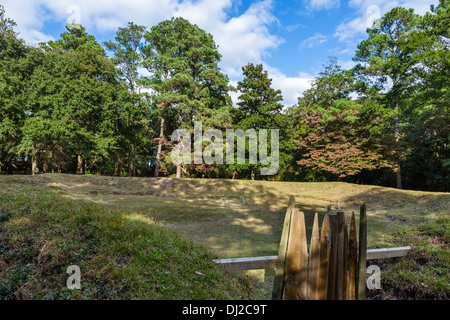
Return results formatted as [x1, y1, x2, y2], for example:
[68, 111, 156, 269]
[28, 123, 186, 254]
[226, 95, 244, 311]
[215, 196, 411, 300]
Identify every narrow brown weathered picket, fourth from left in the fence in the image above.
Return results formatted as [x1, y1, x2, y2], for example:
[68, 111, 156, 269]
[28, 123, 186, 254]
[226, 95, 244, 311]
[317, 214, 331, 300]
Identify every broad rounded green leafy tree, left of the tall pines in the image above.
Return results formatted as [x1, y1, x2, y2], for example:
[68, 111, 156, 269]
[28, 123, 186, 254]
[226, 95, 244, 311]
[20, 26, 129, 174]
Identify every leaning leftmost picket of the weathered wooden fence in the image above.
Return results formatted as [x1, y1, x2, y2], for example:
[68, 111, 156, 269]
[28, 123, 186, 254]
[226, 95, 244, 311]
[272, 196, 295, 300]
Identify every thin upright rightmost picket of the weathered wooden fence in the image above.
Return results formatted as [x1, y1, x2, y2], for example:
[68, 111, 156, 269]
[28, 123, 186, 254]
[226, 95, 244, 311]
[358, 203, 367, 300]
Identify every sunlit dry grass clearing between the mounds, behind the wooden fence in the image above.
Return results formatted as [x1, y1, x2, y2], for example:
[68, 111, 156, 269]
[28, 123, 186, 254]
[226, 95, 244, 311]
[40, 174, 450, 258]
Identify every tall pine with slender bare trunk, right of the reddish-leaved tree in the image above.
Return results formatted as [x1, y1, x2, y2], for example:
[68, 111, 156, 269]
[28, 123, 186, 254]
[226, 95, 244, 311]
[354, 7, 420, 189]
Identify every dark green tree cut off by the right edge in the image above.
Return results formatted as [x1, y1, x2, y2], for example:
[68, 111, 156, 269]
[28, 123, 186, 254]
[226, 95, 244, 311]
[404, 0, 450, 191]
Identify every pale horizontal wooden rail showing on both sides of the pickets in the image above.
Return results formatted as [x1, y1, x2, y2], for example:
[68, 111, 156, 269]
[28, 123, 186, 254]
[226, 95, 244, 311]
[213, 246, 411, 271]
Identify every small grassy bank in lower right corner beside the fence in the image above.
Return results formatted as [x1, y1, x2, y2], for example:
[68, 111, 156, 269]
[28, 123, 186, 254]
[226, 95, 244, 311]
[374, 217, 450, 300]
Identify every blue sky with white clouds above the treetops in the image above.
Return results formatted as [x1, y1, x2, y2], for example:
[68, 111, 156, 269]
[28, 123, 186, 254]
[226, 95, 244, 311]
[0, 0, 439, 106]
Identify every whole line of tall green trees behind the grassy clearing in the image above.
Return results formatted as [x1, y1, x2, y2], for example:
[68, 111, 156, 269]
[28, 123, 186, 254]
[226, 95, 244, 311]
[0, 0, 450, 191]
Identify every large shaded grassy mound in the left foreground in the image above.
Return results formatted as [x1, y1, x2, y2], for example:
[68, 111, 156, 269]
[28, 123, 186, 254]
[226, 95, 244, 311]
[0, 177, 251, 299]
